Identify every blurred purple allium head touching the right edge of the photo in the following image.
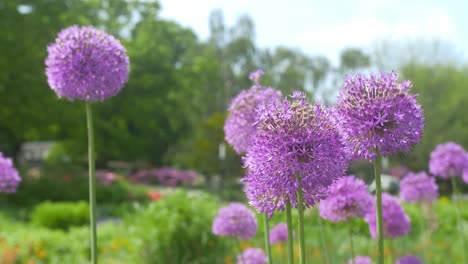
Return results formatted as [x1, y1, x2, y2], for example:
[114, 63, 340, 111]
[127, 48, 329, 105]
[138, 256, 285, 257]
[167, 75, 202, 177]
[429, 142, 468, 179]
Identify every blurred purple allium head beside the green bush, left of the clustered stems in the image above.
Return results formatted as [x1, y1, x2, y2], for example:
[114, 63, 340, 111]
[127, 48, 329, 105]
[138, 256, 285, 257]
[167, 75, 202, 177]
[212, 203, 257, 239]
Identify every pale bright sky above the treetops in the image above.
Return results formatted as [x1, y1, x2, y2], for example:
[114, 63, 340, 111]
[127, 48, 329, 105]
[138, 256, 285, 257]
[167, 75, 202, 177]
[160, 0, 468, 64]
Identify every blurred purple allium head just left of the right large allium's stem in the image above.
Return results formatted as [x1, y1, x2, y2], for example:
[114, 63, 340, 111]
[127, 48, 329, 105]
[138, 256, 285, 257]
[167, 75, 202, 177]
[319, 175, 372, 222]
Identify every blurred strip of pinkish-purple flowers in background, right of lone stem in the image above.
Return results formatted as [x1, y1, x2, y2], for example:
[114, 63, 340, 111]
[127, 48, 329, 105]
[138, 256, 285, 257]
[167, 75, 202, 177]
[130, 167, 199, 187]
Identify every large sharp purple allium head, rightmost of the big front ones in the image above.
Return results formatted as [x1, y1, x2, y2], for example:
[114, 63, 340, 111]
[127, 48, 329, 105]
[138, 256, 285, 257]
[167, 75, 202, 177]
[336, 72, 424, 159]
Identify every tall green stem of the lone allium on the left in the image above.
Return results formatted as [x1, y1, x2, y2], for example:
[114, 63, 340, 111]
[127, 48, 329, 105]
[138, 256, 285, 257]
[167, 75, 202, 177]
[86, 102, 98, 264]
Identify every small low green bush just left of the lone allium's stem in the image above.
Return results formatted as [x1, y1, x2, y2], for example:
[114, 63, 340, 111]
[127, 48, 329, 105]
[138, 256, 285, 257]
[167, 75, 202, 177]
[31, 201, 89, 230]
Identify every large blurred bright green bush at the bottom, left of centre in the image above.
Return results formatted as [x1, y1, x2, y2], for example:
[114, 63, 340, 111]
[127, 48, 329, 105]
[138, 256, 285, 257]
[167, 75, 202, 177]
[127, 190, 229, 264]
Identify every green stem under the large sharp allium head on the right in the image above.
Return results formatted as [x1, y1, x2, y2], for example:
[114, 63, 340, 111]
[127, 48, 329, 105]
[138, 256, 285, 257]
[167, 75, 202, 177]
[374, 153, 384, 264]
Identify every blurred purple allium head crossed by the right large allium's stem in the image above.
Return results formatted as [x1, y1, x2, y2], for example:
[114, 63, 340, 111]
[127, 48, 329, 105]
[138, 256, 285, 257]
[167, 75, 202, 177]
[365, 193, 411, 238]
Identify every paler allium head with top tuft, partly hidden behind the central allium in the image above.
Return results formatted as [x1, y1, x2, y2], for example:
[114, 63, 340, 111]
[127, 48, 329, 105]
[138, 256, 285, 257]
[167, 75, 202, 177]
[224, 70, 281, 154]
